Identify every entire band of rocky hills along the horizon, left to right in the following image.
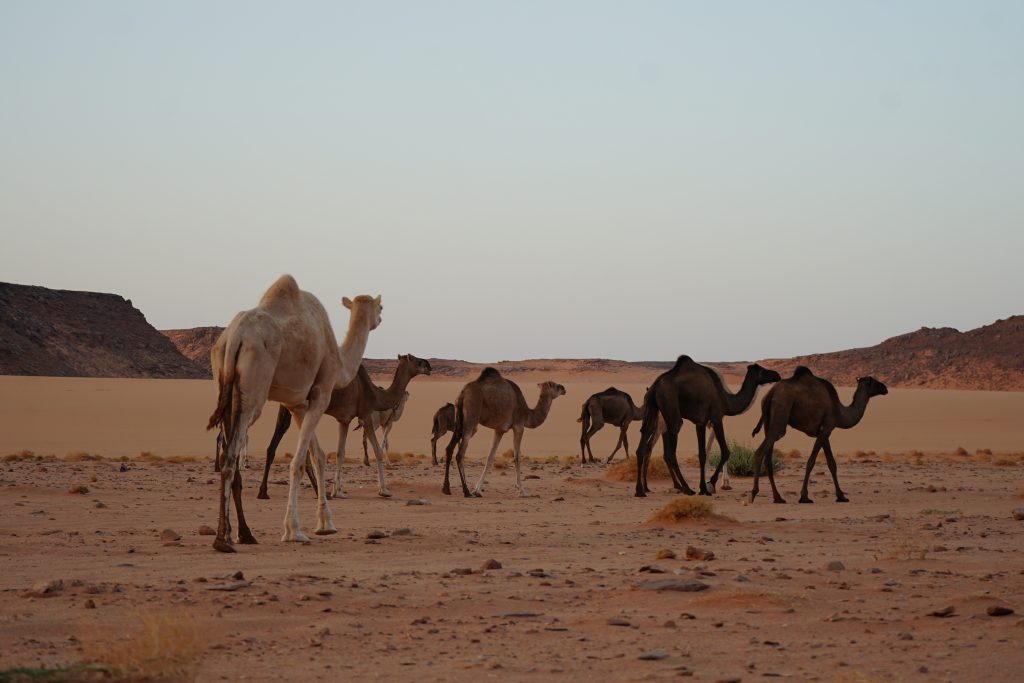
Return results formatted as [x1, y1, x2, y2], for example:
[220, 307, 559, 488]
[0, 283, 1024, 391]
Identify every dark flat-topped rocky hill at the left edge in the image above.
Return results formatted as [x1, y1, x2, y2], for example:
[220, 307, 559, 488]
[0, 283, 203, 378]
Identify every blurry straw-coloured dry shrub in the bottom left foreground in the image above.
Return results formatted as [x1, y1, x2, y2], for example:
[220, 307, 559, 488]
[82, 608, 213, 681]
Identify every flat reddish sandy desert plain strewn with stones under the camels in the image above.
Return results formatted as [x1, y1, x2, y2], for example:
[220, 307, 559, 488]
[0, 376, 1024, 681]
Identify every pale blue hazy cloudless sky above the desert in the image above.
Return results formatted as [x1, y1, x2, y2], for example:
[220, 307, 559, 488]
[0, 0, 1024, 360]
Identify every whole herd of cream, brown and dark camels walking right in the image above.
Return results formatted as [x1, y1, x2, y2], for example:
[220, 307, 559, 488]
[207, 275, 888, 552]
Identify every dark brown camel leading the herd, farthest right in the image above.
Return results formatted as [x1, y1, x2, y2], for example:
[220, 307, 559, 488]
[750, 366, 889, 503]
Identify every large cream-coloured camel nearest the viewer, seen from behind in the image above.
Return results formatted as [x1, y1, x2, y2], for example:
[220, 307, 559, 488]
[207, 274, 382, 553]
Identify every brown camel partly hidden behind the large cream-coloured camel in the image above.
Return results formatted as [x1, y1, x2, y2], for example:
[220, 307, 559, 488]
[258, 354, 430, 498]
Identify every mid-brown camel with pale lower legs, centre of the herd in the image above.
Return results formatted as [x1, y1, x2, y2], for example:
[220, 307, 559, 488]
[441, 368, 565, 498]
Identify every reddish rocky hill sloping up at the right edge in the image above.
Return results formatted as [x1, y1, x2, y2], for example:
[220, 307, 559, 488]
[761, 315, 1024, 391]
